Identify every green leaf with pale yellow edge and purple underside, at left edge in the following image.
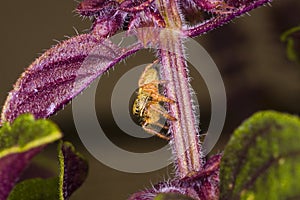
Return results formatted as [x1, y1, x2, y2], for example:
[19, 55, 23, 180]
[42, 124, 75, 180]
[0, 114, 62, 199]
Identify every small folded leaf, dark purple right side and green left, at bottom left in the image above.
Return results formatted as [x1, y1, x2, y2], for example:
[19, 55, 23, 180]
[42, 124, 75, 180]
[6, 142, 88, 200]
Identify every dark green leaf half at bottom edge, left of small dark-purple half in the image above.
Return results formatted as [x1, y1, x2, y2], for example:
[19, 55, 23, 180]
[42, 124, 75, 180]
[8, 178, 58, 200]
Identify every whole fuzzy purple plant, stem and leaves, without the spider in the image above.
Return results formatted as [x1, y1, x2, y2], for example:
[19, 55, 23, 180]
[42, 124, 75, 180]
[0, 0, 271, 200]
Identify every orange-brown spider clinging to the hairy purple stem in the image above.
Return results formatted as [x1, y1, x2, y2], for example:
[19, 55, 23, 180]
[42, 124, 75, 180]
[132, 61, 176, 140]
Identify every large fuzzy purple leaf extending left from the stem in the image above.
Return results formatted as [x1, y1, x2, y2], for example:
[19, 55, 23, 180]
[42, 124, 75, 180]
[2, 29, 140, 122]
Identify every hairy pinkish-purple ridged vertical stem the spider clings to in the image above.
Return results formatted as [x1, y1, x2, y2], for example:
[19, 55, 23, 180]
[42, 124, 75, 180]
[157, 0, 202, 178]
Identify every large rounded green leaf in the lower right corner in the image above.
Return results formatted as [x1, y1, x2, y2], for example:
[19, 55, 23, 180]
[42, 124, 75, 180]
[220, 111, 300, 200]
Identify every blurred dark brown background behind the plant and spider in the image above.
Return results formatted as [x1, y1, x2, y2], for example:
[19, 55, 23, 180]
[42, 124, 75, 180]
[0, 0, 300, 200]
